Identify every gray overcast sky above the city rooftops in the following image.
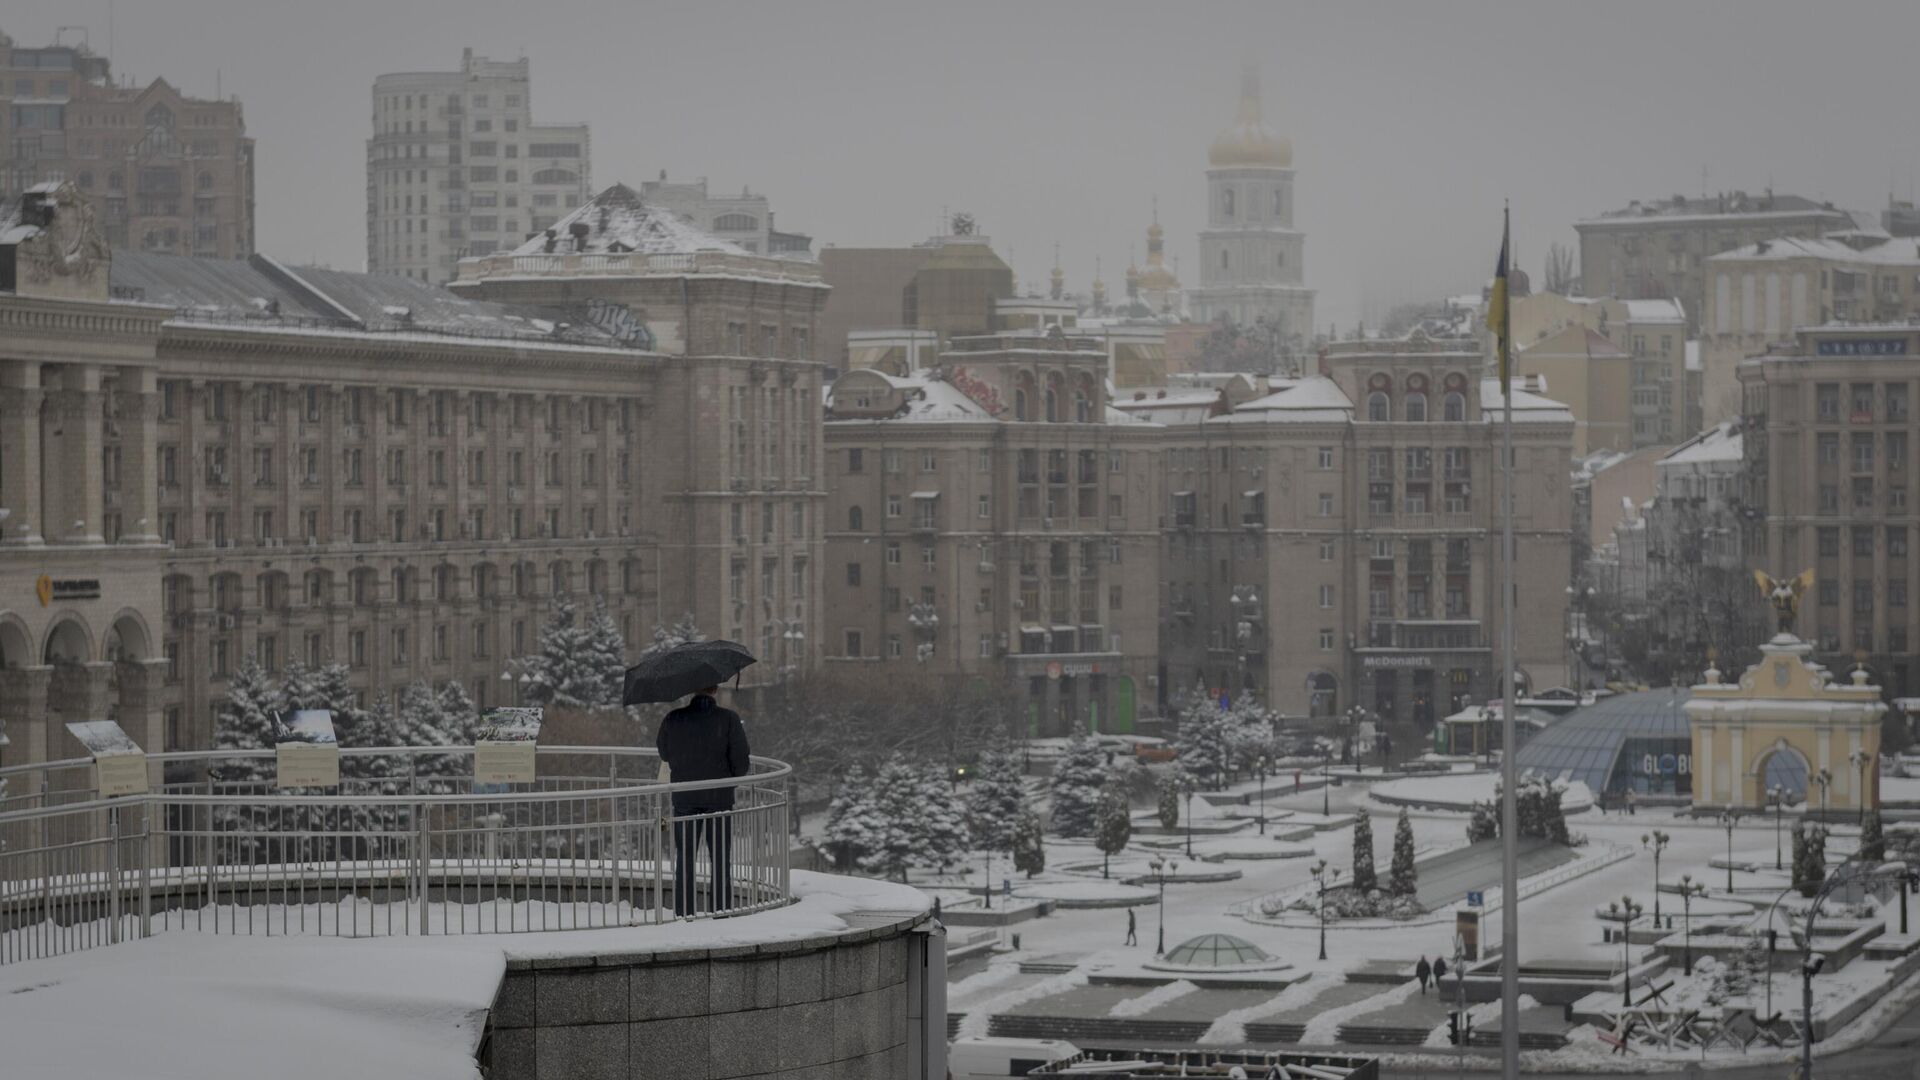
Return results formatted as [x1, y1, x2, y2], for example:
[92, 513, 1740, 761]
[0, 0, 1920, 329]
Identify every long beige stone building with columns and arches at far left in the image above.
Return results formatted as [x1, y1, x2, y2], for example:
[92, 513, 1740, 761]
[0, 186, 826, 763]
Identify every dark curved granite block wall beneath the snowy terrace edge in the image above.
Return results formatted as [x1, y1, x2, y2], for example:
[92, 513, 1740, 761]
[480, 915, 927, 1080]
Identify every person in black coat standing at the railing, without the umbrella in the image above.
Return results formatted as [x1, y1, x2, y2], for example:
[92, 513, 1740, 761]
[655, 686, 751, 915]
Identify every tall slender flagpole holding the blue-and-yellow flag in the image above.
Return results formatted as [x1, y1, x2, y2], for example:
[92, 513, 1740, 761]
[1500, 208, 1521, 1080]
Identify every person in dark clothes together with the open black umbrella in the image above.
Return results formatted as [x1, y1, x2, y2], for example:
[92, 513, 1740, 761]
[622, 642, 755, 915]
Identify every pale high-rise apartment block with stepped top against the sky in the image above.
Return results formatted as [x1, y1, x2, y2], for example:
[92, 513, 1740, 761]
[367, 48, 591, 282]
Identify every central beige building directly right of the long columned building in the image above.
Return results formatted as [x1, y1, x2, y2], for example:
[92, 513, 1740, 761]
[822, 328, 1162, 734]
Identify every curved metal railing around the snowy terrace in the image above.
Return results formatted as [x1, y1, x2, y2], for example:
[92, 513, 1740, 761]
[0, 746, 793, 965]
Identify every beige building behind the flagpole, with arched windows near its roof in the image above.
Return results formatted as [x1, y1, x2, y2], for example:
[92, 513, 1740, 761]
[1158, 334, 1574, 723]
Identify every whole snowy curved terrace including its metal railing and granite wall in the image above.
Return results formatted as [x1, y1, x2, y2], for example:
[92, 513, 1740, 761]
[0, 748, 943, 1080]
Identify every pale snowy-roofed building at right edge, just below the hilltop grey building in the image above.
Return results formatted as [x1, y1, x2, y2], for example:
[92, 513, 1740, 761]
[1701, 233, 1920, 423]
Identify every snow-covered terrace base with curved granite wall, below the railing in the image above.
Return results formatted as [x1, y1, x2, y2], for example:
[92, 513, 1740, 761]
[0, 871, 945, 1080]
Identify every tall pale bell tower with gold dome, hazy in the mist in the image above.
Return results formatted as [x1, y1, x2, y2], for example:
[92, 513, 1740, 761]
[1188, 61, 1313, 354]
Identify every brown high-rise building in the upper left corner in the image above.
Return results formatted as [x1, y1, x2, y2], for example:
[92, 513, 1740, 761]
[0, 33, 253, 259]
